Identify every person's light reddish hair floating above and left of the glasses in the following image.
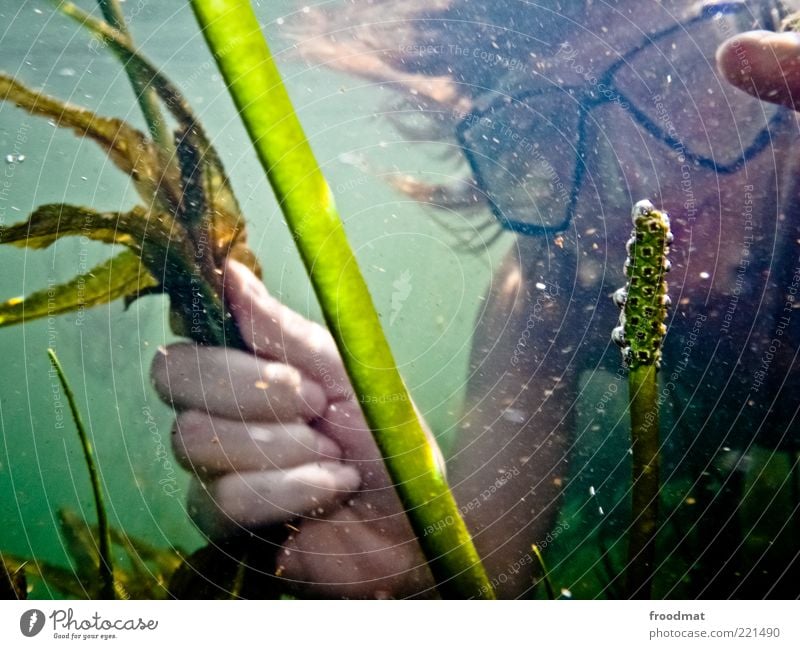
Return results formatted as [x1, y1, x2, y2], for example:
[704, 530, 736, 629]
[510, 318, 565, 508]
[293, 0, 592, 244]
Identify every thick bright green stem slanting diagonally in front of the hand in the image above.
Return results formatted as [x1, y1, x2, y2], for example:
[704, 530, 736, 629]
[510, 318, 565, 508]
[191, 0, 494, 598]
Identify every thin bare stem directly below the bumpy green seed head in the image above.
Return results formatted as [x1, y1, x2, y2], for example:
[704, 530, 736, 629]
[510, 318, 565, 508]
[627, 365, 660, 599]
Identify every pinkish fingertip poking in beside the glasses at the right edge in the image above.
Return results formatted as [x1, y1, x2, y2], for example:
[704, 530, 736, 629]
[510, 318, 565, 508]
[717, 30, 800, 110]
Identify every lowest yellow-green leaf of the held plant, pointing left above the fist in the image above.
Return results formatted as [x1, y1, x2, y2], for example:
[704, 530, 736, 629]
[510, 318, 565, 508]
[0, 251, 159, 327]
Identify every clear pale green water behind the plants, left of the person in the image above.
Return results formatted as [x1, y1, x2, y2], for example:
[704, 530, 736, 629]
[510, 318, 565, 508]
[0, 1, 505, 597]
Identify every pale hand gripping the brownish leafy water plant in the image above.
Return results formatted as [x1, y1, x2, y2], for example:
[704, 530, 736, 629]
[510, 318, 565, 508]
[152, 261, 432, 597]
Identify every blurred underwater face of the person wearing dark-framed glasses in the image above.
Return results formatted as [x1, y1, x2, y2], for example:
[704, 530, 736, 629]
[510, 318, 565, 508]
[459, 0, 792, 292]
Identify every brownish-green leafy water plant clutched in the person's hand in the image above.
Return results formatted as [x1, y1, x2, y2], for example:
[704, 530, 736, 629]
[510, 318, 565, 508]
[0, 13, 258, 347]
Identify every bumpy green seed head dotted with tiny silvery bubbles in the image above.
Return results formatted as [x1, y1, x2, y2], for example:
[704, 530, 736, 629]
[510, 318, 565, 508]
[611, 201, 672, 367]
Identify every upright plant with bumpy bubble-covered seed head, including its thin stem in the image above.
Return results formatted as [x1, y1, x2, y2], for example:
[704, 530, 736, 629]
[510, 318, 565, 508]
[612, 201, 672, 599]
